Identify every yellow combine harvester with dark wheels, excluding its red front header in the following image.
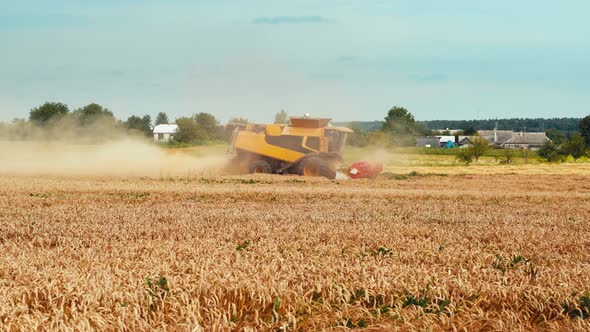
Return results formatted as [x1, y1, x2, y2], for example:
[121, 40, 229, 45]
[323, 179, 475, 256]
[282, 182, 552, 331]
[228, 117, 353, 179]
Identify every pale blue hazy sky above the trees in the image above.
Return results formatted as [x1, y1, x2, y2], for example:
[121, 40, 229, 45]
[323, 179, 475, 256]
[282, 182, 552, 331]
[0, 0, 590, 122]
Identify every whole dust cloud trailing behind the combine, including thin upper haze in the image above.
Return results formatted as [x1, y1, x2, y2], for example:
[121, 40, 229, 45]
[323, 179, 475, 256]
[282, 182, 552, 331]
[0, 118, 227, 177]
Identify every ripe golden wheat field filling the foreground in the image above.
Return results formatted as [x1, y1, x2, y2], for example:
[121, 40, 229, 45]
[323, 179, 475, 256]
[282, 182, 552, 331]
[0, 175, 590, 331]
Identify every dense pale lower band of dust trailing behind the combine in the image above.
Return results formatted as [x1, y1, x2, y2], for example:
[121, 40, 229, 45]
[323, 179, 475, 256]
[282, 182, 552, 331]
[0, 138, 227, 177]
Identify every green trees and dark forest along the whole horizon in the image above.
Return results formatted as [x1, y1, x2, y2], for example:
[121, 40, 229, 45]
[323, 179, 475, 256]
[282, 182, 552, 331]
[0, 102, 590, 161]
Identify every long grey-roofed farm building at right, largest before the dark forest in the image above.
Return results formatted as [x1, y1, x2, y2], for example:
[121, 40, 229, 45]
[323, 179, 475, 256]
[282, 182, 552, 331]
[478, 130, 549, 150]
